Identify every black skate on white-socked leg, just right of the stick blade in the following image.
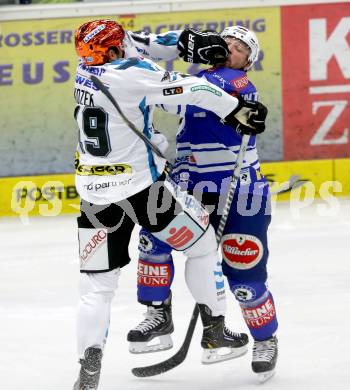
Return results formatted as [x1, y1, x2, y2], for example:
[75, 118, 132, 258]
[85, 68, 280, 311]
[198, 304, 248, 364]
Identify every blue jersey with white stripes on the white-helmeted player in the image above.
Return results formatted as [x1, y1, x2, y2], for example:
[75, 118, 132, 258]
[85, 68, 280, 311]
[172, 68, 267, 198]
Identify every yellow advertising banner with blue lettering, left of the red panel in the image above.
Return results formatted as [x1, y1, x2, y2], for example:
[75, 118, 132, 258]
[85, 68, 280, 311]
[0, 7, 281, 176]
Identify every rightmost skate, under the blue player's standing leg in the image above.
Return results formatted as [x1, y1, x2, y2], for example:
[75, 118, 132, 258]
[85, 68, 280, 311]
[252, 336, 278, 382]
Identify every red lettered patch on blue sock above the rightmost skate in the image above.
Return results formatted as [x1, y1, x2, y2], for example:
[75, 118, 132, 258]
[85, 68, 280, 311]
[242, 297, 276, 329]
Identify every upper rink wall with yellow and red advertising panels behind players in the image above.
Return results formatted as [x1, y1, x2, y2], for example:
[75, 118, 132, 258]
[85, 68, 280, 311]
[0, 0, 350, 177]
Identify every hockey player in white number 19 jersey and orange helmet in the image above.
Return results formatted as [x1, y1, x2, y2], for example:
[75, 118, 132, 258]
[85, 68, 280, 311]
[74, 20, 268, 390]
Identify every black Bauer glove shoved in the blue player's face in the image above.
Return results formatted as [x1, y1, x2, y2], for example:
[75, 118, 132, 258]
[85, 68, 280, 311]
[177, 28, 229, 65]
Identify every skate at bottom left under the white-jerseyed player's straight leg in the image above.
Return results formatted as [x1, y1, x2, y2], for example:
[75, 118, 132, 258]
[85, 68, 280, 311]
[73, 347, 102, 390]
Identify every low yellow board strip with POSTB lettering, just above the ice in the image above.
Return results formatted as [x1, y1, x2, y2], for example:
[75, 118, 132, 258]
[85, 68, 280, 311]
[0, 159, 350, 217]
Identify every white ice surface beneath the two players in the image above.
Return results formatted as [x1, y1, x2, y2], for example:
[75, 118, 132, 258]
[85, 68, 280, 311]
[0, 199, 350, 390]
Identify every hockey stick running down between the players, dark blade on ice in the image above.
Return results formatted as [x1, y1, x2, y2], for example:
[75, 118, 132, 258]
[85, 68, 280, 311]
[131, 135, 249, 377]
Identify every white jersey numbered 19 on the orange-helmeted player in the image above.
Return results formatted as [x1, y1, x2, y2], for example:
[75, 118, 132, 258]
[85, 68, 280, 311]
[75, 57, 237, 205]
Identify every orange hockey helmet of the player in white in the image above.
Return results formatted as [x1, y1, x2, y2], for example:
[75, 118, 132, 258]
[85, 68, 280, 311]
[75, 20, 125, 65]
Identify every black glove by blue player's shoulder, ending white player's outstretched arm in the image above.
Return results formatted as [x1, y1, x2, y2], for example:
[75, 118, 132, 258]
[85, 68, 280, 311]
[225, 96, 268, 135]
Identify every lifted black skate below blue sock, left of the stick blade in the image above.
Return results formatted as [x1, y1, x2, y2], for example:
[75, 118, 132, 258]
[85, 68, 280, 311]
[128, 295, 174, 353]
